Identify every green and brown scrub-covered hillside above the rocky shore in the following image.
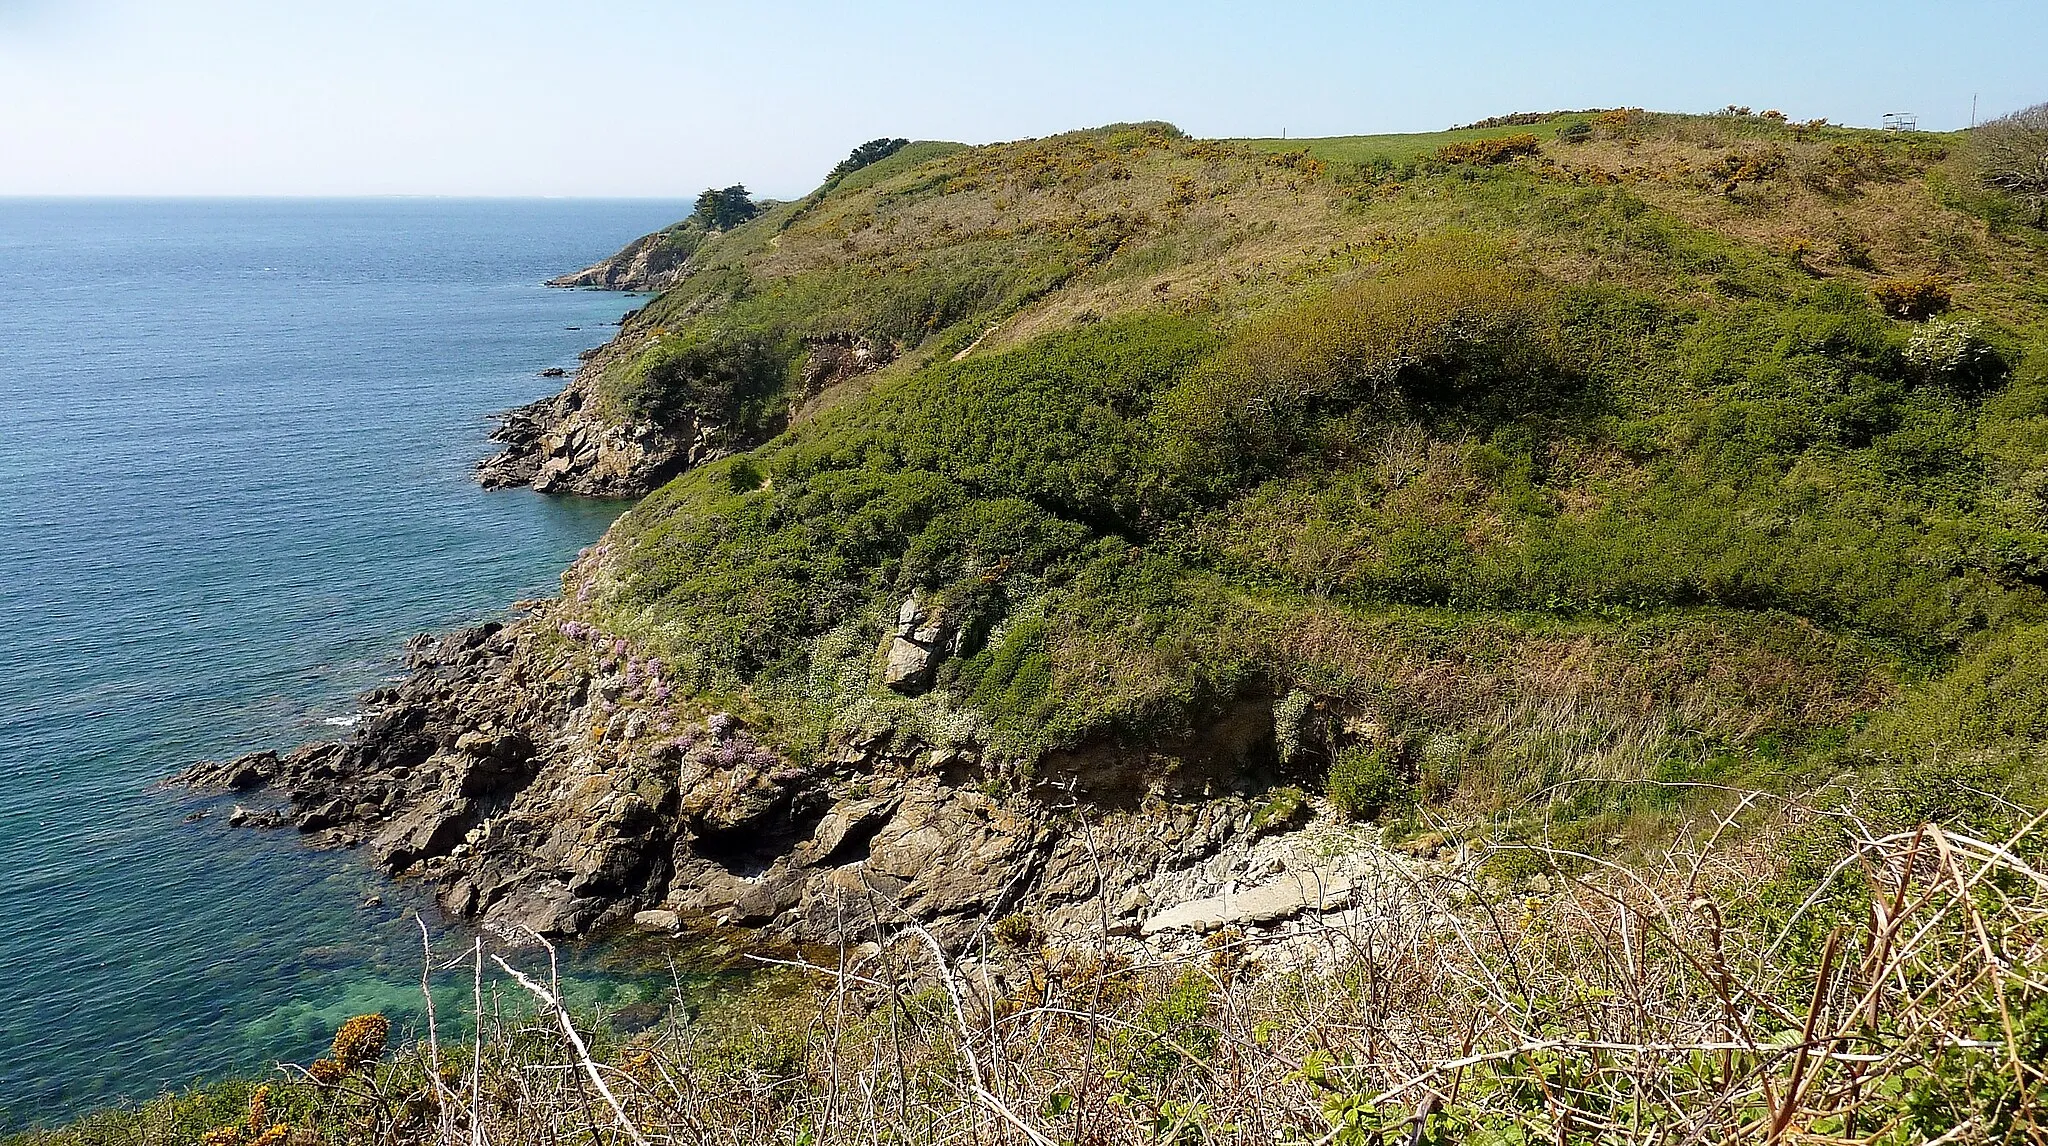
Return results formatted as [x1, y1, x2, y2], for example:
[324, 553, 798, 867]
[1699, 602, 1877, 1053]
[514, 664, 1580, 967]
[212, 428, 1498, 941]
[552, 113, 2048, 843]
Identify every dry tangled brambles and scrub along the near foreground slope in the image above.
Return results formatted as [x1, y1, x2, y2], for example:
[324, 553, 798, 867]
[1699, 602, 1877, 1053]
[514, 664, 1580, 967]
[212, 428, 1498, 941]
[29, 798, 2048, 1146]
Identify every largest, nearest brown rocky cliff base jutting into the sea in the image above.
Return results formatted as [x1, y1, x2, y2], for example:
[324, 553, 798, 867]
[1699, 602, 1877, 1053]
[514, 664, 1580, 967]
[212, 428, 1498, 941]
[182, 606, 1335, 945]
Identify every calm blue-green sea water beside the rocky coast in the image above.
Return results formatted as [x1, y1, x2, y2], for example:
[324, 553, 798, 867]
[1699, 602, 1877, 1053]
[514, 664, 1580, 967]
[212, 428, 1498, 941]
[0, 201, 688, 1130]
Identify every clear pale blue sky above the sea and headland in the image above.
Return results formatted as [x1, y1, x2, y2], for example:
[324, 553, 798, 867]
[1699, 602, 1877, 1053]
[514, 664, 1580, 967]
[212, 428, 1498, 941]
[0, 0, 2048, 196]
